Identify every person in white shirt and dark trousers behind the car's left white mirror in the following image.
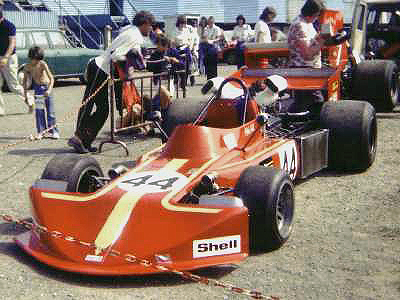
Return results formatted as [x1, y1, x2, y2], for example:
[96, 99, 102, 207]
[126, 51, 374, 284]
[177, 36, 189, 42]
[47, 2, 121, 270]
[204, 16, 224, 80]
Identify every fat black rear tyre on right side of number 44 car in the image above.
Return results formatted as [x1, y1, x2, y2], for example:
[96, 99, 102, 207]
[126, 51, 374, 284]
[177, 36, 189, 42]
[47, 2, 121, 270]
[320, 100, 377, 171]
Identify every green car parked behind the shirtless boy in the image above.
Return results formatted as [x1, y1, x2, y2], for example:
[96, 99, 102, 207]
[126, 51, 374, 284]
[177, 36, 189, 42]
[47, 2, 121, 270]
[16, 28, 103, 83]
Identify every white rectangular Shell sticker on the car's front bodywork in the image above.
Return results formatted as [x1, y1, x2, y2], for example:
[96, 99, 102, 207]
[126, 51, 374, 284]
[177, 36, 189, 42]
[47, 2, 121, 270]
[193, 235, 240, 258]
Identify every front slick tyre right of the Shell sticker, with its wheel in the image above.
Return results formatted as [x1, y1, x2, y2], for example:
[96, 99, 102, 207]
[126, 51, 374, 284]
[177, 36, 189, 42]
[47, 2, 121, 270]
[235, 166, 294, 252]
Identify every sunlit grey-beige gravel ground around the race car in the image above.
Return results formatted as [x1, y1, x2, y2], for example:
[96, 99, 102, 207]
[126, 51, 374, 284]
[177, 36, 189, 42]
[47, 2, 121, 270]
[0, 66, 400, 300]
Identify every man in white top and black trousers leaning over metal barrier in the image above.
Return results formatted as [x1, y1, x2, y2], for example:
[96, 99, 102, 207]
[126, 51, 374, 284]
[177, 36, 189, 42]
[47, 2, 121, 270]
[67, 10, 154, 153]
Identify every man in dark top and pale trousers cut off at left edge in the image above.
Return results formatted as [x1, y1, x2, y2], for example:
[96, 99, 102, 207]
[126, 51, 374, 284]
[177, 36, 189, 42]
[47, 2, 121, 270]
[0, 0, 33, 116]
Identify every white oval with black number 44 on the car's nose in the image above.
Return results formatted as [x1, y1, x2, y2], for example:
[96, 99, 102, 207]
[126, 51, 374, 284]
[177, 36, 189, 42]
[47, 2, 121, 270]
[118, 170, 188, 194]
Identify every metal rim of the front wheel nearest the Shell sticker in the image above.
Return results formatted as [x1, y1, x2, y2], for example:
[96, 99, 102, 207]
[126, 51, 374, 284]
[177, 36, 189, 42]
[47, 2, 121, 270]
[275, 183, 294, 239]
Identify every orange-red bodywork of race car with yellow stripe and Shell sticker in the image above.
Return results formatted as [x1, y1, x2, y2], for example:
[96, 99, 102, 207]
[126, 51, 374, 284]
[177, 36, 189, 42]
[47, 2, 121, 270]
[16, 119, 300, 275]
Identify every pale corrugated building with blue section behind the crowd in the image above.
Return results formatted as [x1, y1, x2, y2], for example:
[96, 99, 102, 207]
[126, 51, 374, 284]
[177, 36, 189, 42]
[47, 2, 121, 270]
[5, 0, 355, 48]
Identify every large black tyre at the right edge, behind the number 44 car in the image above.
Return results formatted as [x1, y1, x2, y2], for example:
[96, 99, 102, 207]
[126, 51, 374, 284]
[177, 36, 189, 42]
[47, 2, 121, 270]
[352, 60, 399, 112]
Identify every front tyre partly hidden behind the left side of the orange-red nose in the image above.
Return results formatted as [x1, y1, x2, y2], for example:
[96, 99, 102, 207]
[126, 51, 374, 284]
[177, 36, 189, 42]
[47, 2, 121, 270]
[41, 153, 103, 193]
